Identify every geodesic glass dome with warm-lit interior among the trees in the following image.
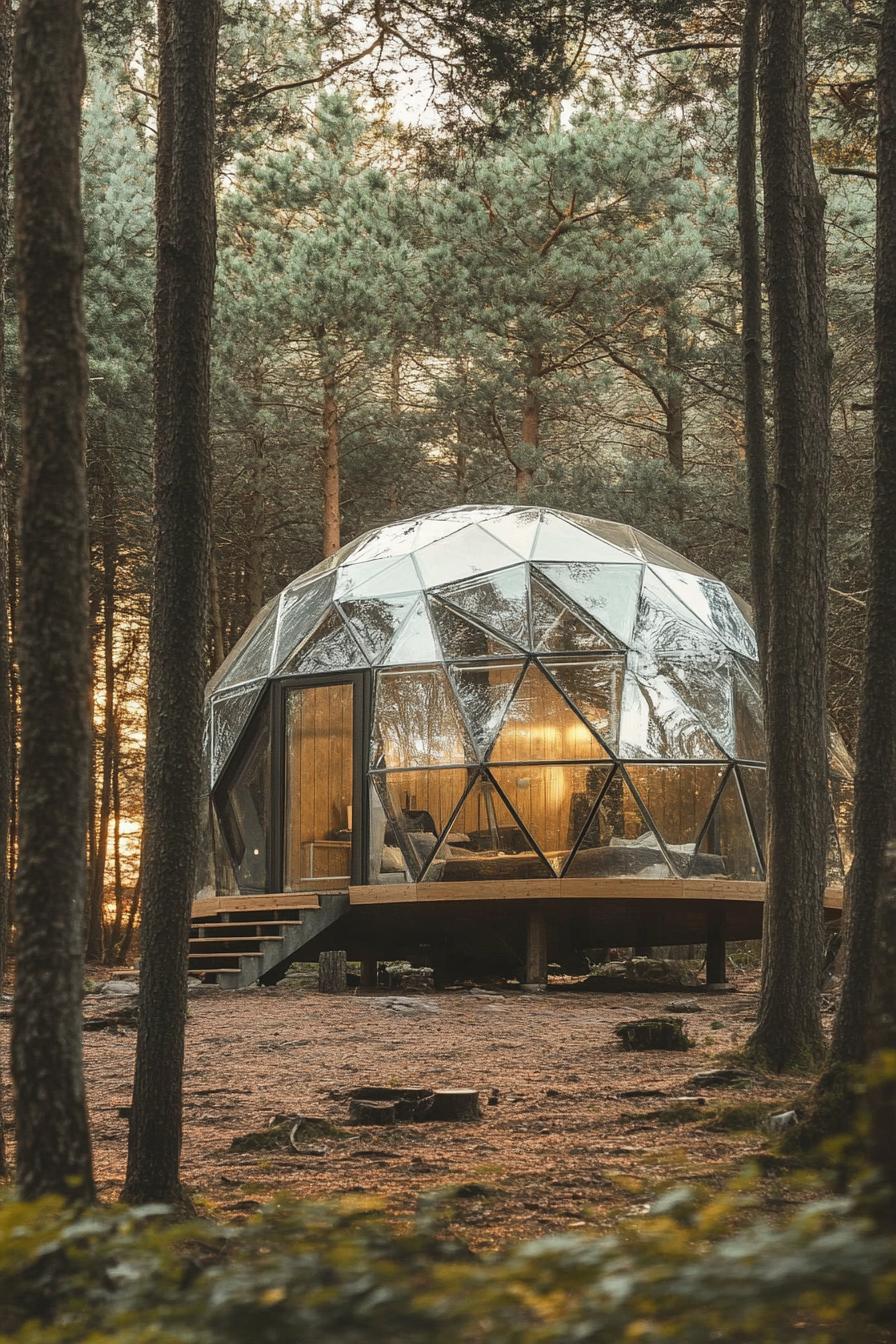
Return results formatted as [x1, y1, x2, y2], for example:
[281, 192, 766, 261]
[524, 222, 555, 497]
[206, 507, 852, 892]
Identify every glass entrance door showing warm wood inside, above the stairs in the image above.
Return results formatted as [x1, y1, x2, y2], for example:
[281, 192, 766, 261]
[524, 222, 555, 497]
[283, 681, 356, 891]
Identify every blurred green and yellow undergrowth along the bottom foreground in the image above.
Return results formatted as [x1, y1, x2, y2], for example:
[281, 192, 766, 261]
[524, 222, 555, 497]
[0, 1176, 896, 1344]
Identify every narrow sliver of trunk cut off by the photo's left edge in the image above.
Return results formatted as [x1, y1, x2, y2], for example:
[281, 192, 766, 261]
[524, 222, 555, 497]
[0, 0, 13, 1177]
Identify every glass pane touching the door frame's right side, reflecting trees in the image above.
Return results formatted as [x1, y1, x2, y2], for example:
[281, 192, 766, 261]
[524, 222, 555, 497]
[371, 667, 477, 770]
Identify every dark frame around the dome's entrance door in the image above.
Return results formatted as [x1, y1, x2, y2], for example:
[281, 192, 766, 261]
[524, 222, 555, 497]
[269, 668, 373, 892]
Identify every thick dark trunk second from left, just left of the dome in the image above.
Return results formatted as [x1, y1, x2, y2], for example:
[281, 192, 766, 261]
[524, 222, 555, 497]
[124, 0, 219, 1203]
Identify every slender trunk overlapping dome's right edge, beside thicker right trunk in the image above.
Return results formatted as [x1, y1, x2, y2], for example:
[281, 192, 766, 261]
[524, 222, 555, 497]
[737, 0, 771, 680]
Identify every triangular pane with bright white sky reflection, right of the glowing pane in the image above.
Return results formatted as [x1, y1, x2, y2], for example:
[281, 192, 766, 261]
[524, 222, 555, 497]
[619, 653, 724, 761]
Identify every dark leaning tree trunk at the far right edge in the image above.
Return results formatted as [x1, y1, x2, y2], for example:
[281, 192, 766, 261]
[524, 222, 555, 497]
[830, 0, 896, 1063]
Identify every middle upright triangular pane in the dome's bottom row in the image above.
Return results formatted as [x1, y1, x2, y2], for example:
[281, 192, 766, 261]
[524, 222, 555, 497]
[564, 767, 672, 878]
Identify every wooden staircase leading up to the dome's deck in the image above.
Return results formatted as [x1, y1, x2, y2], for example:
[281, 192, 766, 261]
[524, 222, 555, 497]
[188, 891, 348, 989]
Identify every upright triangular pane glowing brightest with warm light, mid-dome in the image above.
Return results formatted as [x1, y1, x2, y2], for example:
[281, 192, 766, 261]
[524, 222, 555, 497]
[489, 663, 607, 761]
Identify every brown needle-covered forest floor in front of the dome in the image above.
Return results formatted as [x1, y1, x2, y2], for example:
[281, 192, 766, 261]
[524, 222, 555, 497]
[0, 976, 832, 1247]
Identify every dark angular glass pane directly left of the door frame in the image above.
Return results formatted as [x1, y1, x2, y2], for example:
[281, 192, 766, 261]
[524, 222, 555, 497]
[218, 703, 270, 892]
